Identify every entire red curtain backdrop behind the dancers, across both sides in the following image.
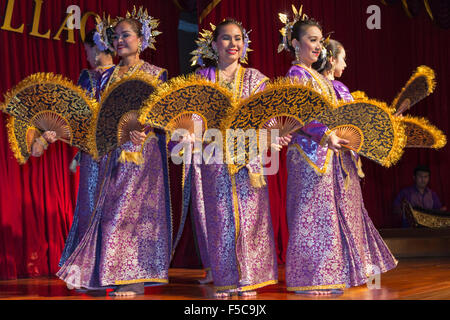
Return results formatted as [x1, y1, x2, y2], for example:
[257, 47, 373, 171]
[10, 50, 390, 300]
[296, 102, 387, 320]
[0, 0, 450, 279]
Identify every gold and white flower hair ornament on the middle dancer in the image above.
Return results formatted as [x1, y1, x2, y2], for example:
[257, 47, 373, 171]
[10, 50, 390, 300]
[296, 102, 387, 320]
[191, 19, 253, 67]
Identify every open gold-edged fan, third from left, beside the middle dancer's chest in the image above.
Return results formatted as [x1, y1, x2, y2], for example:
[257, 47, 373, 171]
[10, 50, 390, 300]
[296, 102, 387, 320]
[139, 75, 234, 139]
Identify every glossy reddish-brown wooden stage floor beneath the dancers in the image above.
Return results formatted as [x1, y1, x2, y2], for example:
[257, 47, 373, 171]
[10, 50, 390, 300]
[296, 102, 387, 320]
[0, 257, 450, 300]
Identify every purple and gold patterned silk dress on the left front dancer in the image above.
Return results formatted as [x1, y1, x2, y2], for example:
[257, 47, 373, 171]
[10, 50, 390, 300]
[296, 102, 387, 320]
[57, 63, 172, 289]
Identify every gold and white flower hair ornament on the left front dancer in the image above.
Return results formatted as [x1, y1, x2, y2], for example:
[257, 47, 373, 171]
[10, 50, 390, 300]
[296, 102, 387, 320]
[119, 6, 162, 51]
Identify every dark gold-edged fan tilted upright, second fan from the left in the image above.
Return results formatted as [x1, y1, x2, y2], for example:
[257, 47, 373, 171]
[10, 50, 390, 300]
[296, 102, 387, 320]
[90, 71, 159, 158]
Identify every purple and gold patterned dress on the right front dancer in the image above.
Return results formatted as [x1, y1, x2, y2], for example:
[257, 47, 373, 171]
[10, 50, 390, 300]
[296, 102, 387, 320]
[286, 65, 397, 291]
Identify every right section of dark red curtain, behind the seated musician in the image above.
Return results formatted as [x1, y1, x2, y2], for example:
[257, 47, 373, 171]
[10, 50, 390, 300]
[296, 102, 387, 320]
[200, 0, 450, 262]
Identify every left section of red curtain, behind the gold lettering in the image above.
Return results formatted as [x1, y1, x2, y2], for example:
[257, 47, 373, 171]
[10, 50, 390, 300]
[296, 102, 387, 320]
[0, 0, 179, 279]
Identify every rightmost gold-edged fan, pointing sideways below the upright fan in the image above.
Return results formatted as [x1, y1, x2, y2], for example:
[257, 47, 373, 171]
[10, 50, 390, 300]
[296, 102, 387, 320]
[401, 116, 447, 149]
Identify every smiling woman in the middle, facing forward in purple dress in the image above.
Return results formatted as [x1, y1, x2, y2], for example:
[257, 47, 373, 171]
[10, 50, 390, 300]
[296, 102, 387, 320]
[192, 19, 278, 298]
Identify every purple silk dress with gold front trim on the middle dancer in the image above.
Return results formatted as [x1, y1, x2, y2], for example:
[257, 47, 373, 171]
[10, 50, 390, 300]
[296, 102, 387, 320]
[194, 66, 278, 291]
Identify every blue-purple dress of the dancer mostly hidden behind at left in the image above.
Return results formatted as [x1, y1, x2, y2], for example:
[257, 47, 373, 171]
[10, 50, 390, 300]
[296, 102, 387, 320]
[59, 68, 114, 267]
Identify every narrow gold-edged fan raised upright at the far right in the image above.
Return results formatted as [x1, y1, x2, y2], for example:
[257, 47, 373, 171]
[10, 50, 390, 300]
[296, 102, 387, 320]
[392, 66, 436, 115]
